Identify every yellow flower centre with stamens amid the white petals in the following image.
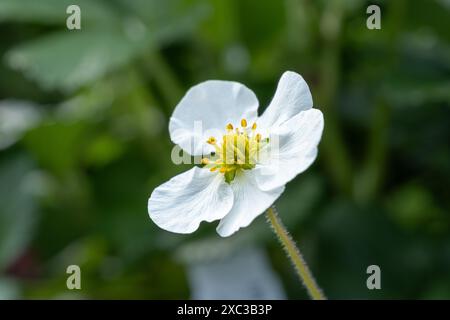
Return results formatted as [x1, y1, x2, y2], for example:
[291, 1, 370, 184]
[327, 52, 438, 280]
[202, 119, 269, 183]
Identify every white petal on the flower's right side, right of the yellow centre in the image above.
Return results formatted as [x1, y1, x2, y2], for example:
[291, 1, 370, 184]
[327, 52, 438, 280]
[254, 109, 323, 190]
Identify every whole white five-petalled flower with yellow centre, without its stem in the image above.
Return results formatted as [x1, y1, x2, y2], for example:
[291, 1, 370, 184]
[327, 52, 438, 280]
[148, 71, 323, 237]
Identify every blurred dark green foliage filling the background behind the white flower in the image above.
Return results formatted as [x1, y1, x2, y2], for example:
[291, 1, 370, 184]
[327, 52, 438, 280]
[0, 0, 450, 299]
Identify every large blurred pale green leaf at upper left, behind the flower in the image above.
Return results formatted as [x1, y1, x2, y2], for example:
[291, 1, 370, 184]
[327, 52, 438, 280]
[6, 0, 204, 91]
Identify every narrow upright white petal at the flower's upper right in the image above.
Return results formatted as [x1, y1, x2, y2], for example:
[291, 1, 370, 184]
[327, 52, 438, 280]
[258, 71, 313, 128]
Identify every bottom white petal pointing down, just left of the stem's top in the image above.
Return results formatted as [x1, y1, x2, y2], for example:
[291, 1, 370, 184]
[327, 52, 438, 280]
[217, 170, 284, 237]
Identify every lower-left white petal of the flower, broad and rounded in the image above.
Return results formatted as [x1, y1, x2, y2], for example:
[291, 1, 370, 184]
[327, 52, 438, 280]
[148, 167, 233, 233]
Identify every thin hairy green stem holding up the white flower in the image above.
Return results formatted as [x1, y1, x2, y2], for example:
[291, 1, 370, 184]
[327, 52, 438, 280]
[267, 206, 326, 300]
